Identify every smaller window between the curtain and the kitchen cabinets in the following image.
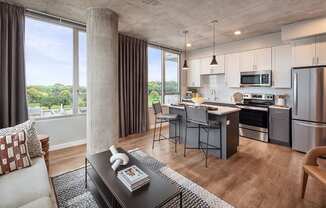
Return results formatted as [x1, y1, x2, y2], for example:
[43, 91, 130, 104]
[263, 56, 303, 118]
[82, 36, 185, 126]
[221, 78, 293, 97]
[148, 46, 180, 107]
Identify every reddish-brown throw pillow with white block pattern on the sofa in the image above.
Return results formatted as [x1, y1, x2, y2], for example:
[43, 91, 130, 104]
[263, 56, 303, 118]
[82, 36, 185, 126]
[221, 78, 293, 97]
[0, 131, 32, 175]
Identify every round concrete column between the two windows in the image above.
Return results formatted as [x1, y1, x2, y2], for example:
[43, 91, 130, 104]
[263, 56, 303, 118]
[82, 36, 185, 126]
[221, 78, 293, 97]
[87, 8, 119, 154]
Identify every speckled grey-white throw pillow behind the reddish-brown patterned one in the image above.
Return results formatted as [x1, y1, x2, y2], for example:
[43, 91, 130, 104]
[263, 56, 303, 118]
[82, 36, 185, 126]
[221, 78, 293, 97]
[0, 120, 43, 158]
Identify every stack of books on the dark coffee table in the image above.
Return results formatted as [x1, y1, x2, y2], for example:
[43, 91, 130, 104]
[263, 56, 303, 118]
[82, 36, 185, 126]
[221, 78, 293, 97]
[118, 165, 150, 192]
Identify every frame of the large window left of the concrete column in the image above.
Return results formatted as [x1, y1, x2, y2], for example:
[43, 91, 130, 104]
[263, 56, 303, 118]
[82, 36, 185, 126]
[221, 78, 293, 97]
[25, 12, 87, 120]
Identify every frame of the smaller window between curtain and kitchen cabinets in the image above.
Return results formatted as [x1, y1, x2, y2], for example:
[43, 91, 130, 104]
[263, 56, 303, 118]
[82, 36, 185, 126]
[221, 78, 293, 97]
[147, 43, 181, 105]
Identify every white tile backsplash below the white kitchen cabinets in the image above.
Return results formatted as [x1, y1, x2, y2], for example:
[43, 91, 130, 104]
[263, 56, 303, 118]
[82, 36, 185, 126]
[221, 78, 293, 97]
[199, 74, 292, 106]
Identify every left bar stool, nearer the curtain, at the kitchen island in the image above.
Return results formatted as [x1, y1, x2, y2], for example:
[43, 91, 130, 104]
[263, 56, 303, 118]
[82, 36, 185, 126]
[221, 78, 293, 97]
[152, 102, 180, 152]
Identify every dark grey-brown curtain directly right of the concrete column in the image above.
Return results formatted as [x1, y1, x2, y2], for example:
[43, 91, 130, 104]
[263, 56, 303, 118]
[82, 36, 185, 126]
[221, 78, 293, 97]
[119, 34, 148, 137]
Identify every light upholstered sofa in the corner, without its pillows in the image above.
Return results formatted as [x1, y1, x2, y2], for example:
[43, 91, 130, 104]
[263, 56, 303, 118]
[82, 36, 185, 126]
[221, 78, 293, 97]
[0, 157, 53, 208]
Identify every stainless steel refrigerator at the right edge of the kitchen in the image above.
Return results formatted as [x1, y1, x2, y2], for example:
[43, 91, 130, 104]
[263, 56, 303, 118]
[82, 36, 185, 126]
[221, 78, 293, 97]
[292, 66, 326, 152]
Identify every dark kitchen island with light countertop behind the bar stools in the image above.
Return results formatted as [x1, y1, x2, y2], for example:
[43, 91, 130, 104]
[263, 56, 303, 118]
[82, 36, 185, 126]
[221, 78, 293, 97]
[168, 103, 240, 159]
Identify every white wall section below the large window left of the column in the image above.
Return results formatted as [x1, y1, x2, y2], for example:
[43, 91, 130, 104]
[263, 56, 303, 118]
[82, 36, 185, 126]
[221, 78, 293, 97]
[36, 115, 86, 150]
